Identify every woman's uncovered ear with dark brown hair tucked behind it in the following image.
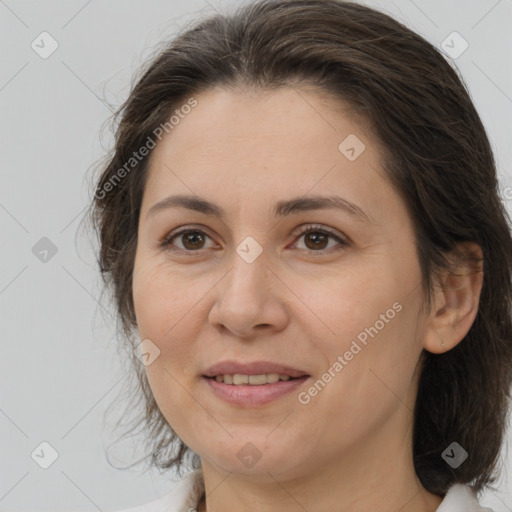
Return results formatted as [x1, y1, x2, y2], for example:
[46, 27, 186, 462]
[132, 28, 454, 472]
[423, 242, 484, 354]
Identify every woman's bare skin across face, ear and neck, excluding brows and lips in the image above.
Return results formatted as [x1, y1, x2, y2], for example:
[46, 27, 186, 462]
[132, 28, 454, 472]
[133, 87, 482, 512]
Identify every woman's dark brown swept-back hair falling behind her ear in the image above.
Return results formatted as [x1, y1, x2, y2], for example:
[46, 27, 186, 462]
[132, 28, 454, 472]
[86, 0, 512, 495]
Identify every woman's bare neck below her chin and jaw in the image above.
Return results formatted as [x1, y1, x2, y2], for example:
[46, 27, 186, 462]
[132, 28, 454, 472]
[198, 406, 442, 512]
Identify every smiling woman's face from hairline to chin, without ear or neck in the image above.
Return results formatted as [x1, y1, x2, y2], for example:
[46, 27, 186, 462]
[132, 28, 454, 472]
[133, 87, 432, 478]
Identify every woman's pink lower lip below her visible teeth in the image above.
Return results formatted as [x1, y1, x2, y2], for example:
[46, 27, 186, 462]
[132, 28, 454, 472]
[203, 375, 309, 405]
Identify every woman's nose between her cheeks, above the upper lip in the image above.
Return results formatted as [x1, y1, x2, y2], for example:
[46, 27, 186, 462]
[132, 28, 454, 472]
[209, 253, 289, 338]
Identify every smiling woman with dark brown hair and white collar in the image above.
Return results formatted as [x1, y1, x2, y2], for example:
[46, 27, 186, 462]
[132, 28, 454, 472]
[86, 0, 512, 512]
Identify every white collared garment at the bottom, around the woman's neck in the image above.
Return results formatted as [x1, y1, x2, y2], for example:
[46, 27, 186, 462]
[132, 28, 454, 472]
[118, 469, 493, 512]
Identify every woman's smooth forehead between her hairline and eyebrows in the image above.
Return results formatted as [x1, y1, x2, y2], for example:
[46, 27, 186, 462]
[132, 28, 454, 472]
[142, 87, 403, 228]
